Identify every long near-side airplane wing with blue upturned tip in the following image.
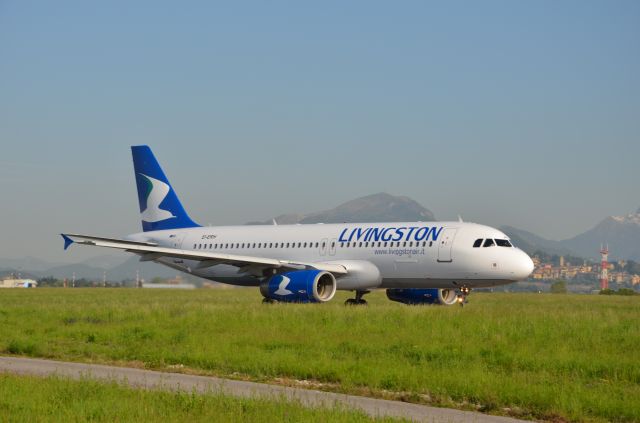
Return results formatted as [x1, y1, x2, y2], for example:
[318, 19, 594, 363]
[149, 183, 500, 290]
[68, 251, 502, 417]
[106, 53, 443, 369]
[61, 234, 347, 275]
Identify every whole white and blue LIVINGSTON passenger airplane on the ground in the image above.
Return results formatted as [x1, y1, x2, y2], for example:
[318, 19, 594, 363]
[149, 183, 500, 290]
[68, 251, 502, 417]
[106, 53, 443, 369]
[61, 145, 533, 305]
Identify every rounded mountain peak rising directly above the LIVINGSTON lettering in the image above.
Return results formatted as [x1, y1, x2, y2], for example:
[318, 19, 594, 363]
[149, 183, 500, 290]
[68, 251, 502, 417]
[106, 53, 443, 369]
[249, 192, 436, 225]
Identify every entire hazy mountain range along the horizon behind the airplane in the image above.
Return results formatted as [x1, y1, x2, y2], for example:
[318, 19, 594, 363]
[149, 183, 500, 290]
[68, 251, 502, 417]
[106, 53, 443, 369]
[0, 193, 640, 281]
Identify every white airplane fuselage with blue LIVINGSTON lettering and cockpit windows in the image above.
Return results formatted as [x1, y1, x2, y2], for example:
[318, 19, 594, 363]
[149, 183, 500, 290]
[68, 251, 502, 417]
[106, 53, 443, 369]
[127, 222, 533, 289]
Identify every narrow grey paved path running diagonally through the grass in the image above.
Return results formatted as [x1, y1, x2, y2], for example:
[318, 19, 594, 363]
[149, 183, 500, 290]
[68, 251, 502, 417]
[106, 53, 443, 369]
[0, 357, 530, 423]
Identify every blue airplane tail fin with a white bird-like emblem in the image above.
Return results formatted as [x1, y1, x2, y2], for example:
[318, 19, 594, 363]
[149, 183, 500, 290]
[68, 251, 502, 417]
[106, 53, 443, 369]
[131, 145, 200, 232]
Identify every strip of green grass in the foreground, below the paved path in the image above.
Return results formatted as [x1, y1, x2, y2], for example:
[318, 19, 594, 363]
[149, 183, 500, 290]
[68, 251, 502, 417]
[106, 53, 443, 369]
[0, 373, 391, 423]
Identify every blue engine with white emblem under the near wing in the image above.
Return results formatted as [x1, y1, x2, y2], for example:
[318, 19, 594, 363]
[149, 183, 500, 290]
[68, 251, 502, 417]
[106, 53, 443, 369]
[260, 270, 336, 303]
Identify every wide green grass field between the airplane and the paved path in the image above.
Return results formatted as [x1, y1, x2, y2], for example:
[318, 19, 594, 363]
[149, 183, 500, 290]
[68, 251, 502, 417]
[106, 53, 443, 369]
[0, 289, 640, 421]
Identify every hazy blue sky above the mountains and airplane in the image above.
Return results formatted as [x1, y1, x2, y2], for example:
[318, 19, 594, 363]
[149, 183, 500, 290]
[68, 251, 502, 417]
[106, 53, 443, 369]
[0, 0, 640, 260]
